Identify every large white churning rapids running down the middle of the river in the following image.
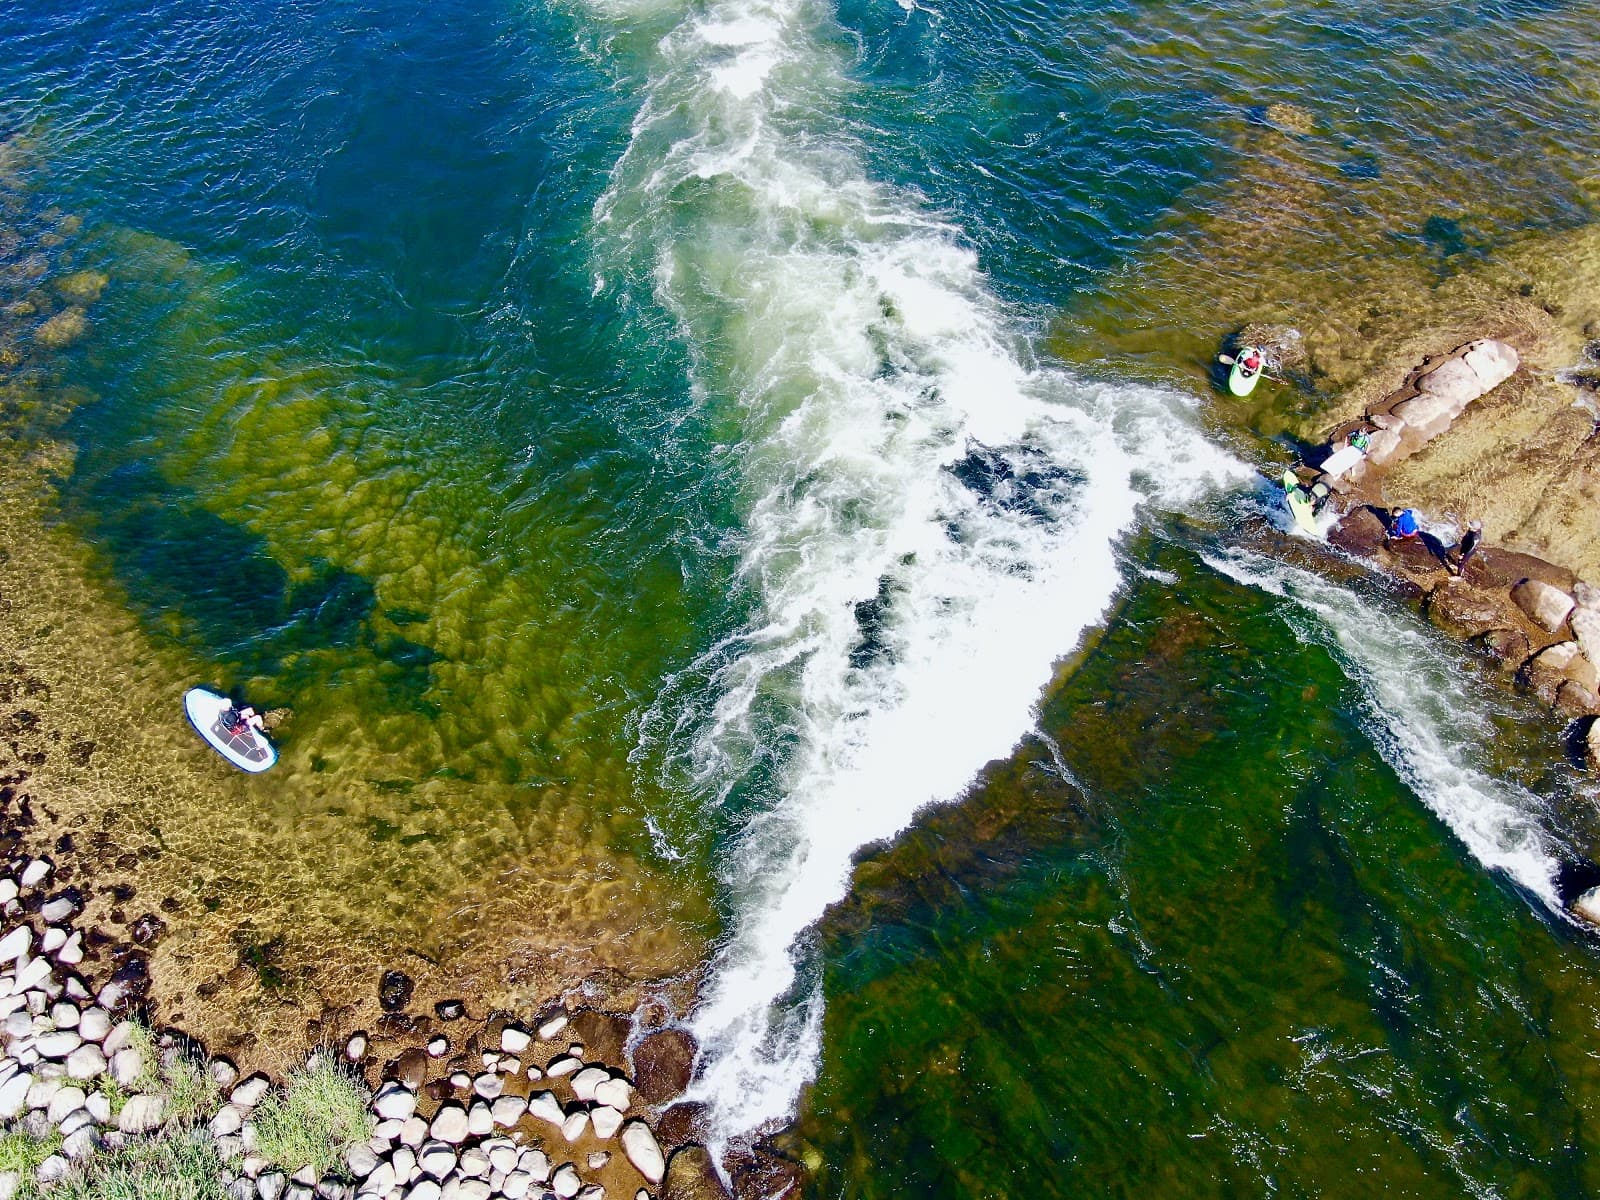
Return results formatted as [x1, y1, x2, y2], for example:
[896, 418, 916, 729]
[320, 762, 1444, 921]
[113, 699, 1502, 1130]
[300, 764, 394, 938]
[582, 0, 1246, 1149]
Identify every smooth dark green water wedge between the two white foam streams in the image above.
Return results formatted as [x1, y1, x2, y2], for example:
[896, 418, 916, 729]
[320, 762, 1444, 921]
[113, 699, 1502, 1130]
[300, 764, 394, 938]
[794, 546, 1600, 1197]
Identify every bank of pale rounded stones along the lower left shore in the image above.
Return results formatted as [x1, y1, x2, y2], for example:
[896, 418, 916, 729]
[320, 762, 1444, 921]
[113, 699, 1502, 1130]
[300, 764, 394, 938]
[0, 825, 800, 1200]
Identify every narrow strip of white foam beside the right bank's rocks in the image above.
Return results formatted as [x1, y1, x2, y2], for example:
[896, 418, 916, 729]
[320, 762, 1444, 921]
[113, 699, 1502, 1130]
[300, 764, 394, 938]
[1206, 550, 1563, 914]
